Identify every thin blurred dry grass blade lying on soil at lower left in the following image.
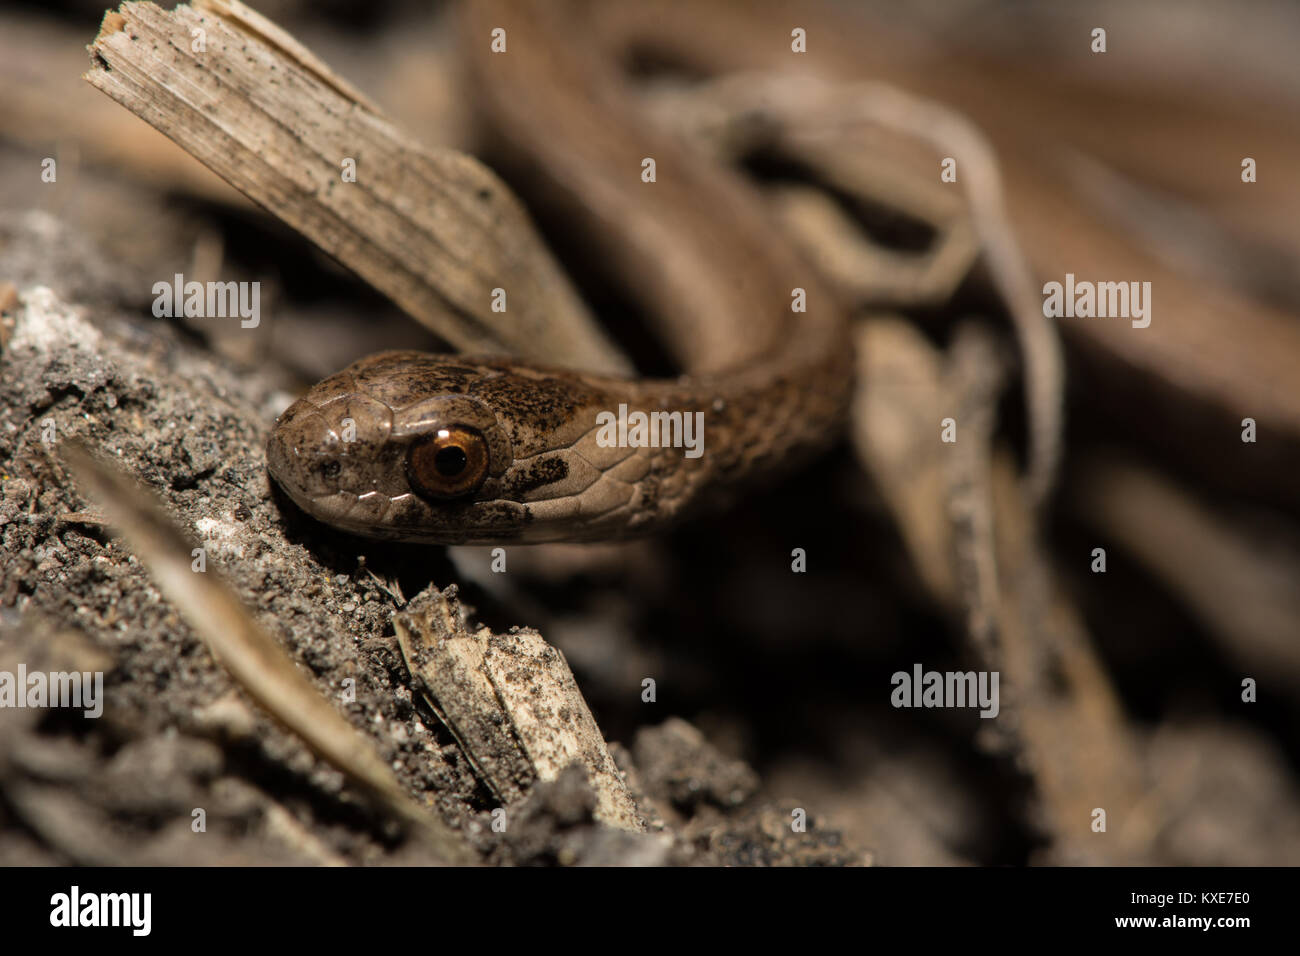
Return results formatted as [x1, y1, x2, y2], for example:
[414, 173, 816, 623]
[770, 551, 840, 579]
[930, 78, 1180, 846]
[61, 441, 471, 864]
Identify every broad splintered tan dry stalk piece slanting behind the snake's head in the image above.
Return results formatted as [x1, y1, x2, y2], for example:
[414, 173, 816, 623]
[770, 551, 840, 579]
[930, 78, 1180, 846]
[86, 0, 629, 372]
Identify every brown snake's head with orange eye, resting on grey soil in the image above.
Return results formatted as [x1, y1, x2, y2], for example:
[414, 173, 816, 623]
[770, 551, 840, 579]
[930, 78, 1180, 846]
[267, 352, 647, 544]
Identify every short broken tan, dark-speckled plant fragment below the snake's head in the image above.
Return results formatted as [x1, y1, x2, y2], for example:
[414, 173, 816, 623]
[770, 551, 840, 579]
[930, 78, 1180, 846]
[393, 588, 645, 831]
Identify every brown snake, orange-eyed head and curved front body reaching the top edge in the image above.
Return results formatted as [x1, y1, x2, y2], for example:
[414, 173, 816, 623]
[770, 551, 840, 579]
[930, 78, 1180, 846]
[267, 0, 854, 545]
